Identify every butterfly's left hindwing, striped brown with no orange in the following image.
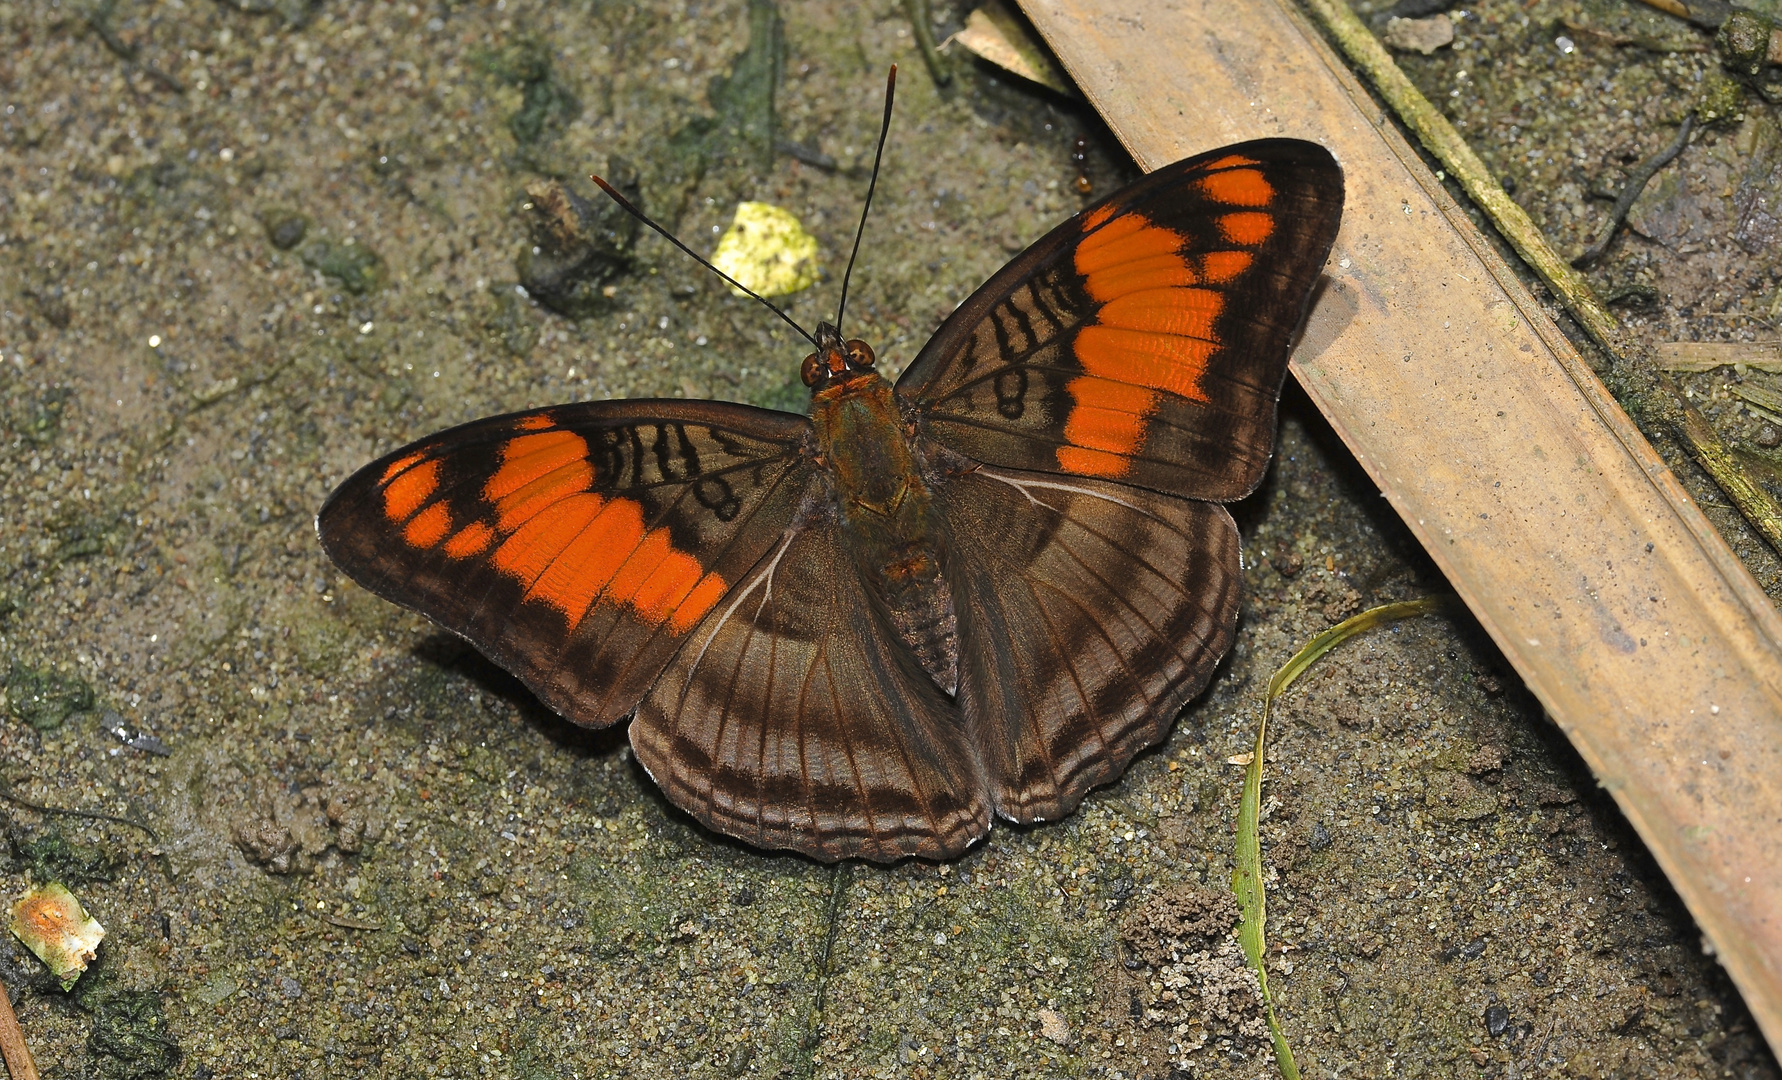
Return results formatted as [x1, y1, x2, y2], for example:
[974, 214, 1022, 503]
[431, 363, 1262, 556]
[631, 495, 991, 863]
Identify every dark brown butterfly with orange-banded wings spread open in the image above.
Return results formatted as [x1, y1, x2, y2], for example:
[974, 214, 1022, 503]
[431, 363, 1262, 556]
[317, 130, 1344, 863]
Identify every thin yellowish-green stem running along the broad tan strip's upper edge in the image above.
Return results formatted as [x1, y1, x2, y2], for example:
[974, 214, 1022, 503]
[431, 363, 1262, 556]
[1304, 0, 1782, 552]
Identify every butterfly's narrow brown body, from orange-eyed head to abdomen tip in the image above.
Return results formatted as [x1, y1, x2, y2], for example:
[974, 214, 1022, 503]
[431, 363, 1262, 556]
[805, 324, 959, 693]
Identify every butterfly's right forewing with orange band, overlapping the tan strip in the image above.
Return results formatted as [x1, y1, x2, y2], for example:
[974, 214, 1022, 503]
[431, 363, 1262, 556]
[898, 139, 1344, 501]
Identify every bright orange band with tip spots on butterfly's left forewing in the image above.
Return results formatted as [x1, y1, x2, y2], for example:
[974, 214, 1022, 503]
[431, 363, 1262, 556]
[368, 417, 729, 634]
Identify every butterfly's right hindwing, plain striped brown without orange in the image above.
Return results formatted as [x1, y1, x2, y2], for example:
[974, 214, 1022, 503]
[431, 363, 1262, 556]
[936, 467, 1240, 822]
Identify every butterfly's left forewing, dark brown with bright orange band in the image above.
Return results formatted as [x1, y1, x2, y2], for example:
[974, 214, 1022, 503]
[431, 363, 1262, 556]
[315, 401, 813, 727]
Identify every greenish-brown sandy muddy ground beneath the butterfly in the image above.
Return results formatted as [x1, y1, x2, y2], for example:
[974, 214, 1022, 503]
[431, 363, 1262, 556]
[0, 0, 1782, 1080]
